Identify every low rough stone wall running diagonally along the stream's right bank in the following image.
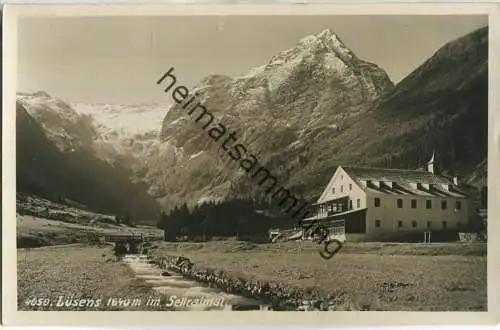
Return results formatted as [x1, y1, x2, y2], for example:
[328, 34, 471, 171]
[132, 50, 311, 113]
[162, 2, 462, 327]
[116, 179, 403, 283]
[145, 255, 360, 311]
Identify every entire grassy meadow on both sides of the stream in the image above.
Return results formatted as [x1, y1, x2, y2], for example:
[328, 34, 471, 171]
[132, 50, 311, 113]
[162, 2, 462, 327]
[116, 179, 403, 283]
[17, 216, 487, 311]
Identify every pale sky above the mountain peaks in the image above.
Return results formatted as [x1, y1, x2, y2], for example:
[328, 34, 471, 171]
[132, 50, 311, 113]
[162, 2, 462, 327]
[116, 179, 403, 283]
[17, 15, 488, 104]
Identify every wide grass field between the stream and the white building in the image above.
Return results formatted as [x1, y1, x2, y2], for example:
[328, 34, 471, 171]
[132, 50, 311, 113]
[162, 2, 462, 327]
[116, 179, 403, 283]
[150, 241, 487, 311]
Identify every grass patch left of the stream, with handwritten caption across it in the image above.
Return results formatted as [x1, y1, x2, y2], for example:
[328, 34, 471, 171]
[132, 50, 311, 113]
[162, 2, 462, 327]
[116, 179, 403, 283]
[17, 246, 170, 311]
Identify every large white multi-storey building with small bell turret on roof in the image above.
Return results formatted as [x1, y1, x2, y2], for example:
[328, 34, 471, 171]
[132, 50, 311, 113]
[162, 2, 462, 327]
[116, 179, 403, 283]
[305, 155, 473, 240]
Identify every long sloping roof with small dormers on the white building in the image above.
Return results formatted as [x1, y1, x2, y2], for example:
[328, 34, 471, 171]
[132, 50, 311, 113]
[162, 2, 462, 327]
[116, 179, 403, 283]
[342, 166, 467, 198]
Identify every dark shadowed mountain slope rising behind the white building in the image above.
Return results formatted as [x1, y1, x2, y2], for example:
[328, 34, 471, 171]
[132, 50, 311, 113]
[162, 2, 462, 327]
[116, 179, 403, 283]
[296, 28, 488, 192]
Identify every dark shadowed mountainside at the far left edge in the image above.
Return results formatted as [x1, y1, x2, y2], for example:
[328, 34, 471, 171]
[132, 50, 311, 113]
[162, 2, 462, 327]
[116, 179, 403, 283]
[16, 102, 160, 224]
